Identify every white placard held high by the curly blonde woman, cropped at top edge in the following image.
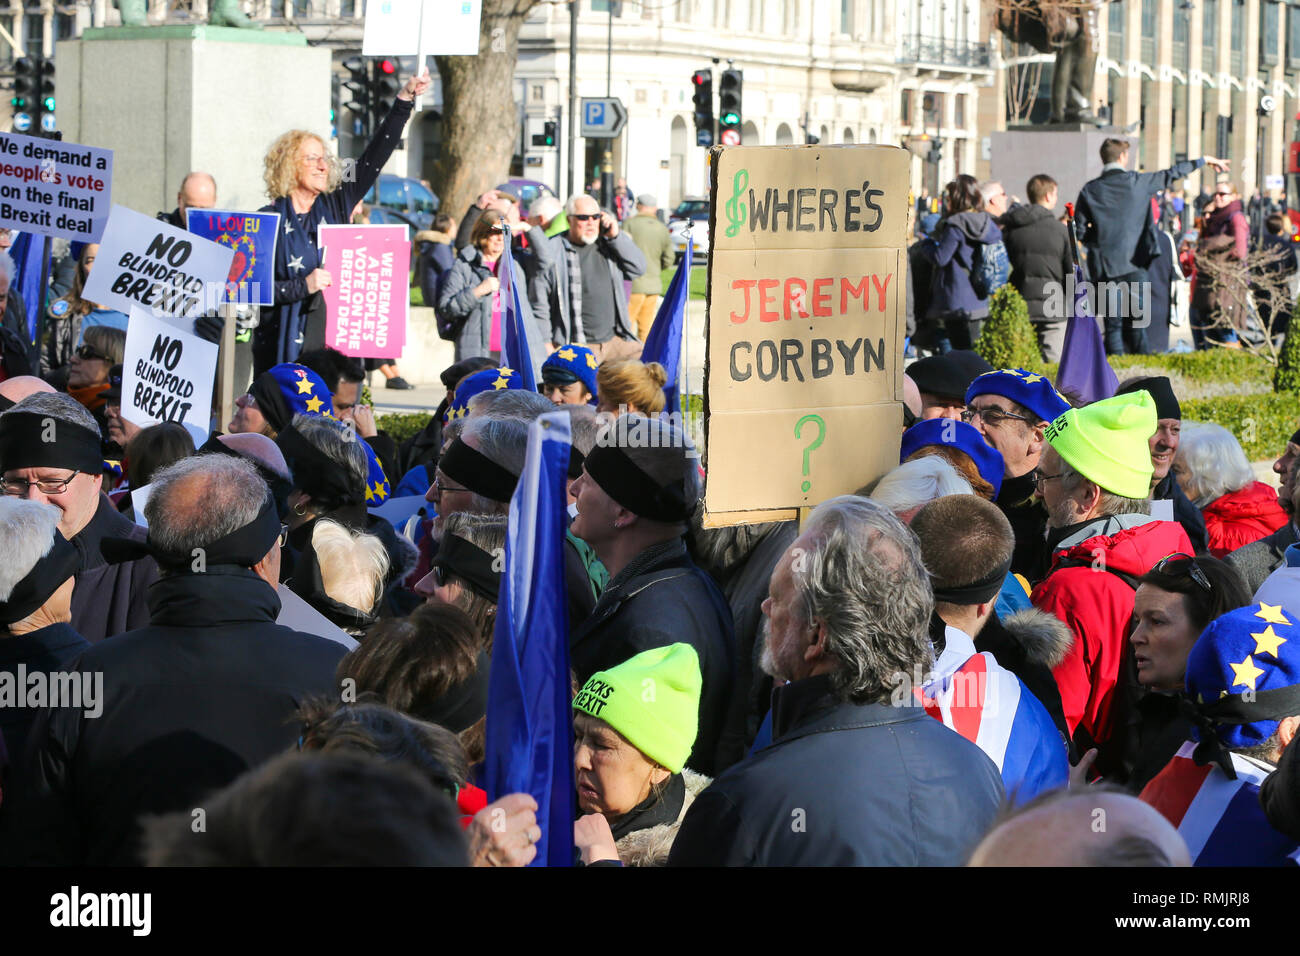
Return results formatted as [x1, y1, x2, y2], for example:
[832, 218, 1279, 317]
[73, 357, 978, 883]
[361, 0, 482, 56]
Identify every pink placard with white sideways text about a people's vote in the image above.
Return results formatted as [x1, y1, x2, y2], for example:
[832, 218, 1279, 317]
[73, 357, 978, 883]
[320, 225, 411, 359]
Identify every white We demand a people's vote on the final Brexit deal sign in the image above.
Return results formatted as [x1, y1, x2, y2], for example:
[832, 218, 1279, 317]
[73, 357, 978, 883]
[0, 133, 113, 242]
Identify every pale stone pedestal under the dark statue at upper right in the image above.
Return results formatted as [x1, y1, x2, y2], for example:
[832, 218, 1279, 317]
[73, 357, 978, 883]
[989, 124, 1138, 213]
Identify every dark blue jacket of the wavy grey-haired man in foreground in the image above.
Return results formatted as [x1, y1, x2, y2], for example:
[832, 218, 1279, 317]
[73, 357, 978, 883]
[668, 675, 1004, 866]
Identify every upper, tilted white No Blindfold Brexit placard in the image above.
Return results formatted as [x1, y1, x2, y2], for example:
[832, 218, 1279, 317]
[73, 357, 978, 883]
[83, 206, 234, 320]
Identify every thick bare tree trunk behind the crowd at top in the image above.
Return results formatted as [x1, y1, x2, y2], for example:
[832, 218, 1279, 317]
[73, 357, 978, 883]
[433, 0, 538, 216]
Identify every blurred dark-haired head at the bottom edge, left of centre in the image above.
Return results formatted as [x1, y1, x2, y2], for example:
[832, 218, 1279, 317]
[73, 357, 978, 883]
[146, 753, 468, 866]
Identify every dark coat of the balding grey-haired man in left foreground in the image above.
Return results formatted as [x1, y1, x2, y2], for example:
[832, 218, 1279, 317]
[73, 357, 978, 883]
[0, 566, 345, 865]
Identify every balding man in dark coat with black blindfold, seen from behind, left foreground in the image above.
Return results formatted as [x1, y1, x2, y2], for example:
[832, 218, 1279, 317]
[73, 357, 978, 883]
[0, 455, 343, 866]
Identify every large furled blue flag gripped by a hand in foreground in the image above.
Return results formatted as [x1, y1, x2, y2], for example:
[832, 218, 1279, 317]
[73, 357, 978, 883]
[484, 412, 575, 866]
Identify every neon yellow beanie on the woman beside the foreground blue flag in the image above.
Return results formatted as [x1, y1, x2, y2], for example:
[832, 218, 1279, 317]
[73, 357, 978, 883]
[573, 644, 702, 774]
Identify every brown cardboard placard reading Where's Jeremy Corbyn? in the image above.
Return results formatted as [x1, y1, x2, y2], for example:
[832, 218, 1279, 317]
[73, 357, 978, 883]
[705, 146, 910, 527]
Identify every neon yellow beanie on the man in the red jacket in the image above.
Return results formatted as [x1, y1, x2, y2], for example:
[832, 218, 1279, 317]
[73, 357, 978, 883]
[1045, 392, 1156, 498]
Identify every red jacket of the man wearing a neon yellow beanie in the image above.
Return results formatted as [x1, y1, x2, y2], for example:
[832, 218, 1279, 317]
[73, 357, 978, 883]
[1031, 515, 1192, 752]
